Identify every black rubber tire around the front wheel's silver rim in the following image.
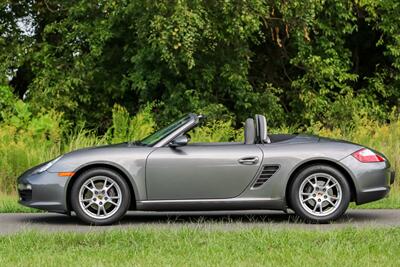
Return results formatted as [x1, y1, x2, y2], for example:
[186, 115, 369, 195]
[70, 168, 131, 225]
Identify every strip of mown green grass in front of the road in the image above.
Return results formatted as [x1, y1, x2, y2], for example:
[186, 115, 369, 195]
[0, 227, 400, 266]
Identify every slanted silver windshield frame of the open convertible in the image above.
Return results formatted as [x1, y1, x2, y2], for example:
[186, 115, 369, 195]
[140, 113, 199, 147]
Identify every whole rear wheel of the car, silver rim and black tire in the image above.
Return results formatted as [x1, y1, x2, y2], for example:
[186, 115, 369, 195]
[289, 165, 351, 223]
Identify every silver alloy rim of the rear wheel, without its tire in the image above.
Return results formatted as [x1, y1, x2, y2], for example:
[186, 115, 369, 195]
[299, 173, 342, 217]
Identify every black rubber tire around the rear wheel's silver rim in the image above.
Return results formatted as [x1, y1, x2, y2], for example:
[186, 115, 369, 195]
[289, 164, 351, 223]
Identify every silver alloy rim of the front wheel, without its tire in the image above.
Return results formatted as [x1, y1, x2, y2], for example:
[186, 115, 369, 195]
[79, 176, 122, 219]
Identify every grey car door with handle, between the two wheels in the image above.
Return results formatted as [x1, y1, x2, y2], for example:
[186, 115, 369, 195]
[146, 144, 263, 200]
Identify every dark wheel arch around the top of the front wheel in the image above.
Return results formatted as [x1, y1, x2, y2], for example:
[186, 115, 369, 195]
[65, 162, 138, 211]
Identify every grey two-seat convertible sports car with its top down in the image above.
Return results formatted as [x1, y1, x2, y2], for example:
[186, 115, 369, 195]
[18, 114, 395, 225]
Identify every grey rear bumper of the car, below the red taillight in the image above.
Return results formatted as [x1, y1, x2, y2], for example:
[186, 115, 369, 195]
[341, 156, 395, 205]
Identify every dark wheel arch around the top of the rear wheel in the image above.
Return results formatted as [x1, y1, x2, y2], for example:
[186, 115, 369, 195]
[284, 159, 357, 206]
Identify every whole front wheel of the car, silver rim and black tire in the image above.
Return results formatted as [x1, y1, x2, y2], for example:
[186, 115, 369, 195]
[71, 168, 131, 225]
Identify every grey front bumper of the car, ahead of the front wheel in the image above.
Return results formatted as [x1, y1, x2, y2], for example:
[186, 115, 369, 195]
[18, 171, 69, 213]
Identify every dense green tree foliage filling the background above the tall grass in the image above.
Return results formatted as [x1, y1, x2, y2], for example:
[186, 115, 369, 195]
[0, 0, 400, 130]
